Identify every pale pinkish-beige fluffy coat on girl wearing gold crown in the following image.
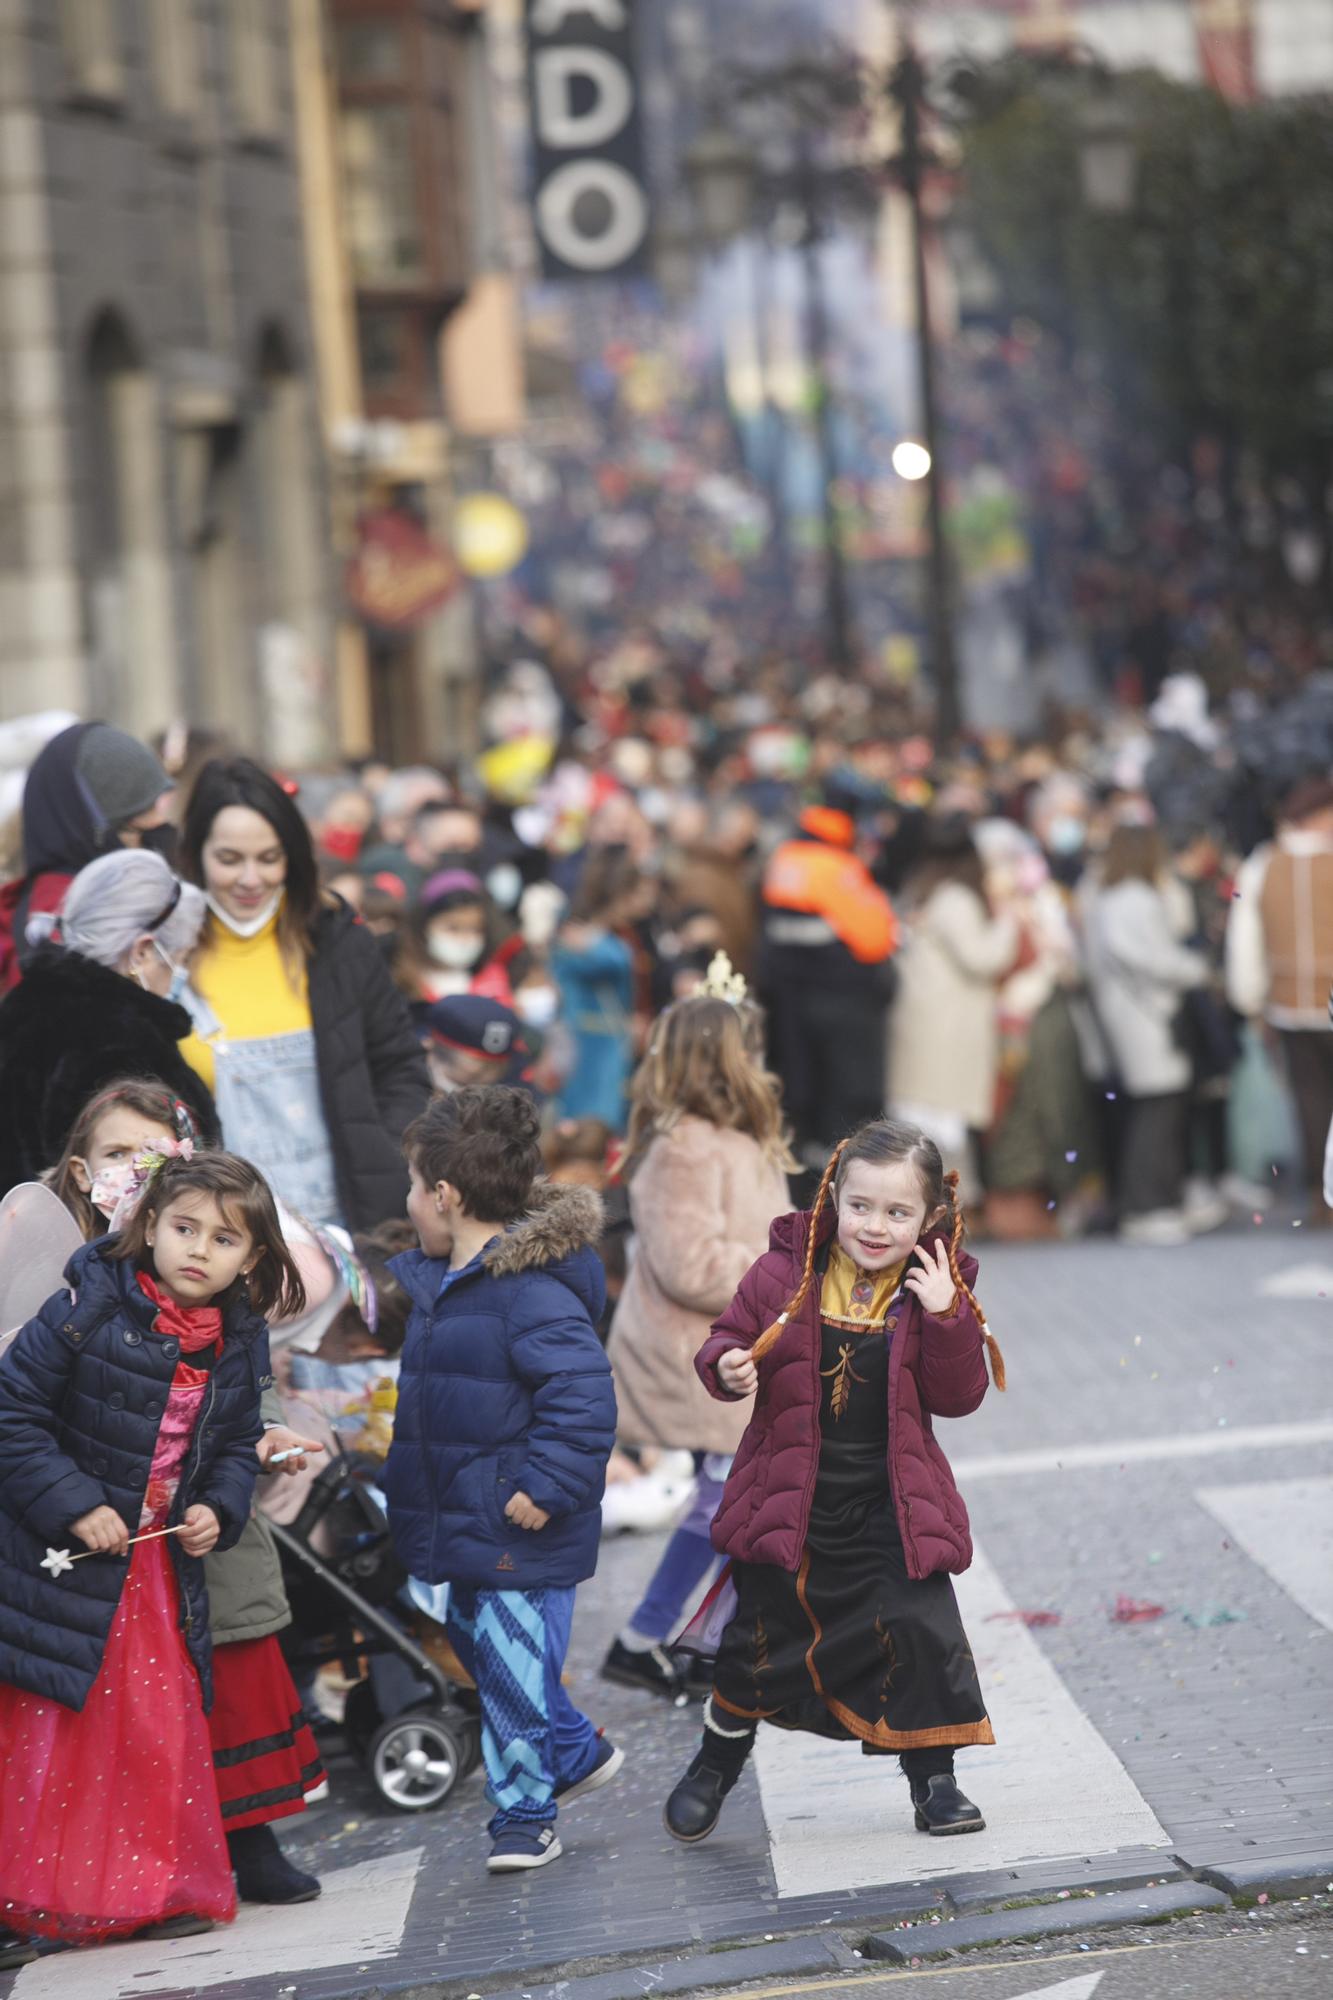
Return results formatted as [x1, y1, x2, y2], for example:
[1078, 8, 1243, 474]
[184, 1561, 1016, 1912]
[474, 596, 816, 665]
[606, 1118, 791, 1452]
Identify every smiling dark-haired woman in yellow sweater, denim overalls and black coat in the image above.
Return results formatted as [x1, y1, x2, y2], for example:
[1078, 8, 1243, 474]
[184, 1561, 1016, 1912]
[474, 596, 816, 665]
[180, 758, 430, 1230]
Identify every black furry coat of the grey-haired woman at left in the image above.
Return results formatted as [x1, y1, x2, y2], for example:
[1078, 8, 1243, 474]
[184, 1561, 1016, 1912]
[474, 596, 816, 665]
[0, 944, 218, 1194]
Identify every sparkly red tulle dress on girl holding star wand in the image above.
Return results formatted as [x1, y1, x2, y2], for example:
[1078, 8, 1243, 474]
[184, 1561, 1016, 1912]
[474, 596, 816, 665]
[0, 1274, 236, 1944]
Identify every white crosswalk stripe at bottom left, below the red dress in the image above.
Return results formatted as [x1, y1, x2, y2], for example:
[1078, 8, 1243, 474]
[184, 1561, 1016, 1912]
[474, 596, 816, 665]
[12, 1848, 424, 2000]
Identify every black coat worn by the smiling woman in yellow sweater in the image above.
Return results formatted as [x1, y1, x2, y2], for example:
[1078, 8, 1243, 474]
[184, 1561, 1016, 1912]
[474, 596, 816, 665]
[308, 902, 430, 1230]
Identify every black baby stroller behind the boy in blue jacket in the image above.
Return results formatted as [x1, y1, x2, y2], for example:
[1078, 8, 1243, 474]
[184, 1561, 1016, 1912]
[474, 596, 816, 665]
[268, 1452, 480, 1812]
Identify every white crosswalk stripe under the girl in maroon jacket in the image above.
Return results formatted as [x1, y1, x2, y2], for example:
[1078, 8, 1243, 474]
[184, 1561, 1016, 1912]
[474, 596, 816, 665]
[755, 1550, 1169, 1896]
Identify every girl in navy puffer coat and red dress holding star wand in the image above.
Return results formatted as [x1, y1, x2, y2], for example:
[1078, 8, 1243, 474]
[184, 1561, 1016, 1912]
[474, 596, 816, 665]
[0, 1154, 302, 1964]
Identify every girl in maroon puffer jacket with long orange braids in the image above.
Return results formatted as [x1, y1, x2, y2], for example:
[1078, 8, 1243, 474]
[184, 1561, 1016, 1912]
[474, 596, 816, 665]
[667, 1120, 1005, 1840]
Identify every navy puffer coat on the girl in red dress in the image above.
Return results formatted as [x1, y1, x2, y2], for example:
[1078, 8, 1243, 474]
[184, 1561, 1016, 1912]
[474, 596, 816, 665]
[0, 1238, 272, 1708]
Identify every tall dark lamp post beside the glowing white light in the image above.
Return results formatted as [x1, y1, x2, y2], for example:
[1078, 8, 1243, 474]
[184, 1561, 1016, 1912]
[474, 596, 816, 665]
[889, 44, 963, 742]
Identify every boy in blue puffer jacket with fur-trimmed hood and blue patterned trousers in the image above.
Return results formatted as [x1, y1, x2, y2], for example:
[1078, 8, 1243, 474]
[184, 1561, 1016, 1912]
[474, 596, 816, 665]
[384, 1086, 624, 1874]
